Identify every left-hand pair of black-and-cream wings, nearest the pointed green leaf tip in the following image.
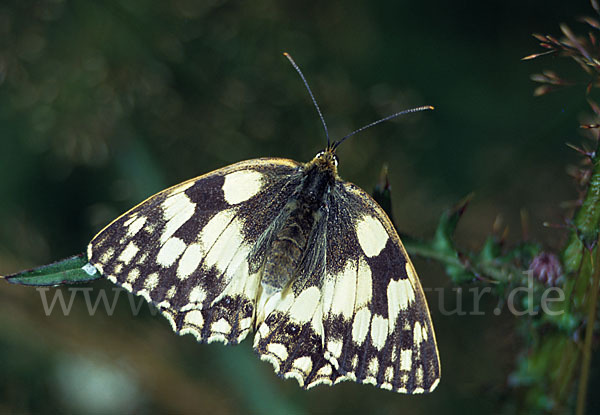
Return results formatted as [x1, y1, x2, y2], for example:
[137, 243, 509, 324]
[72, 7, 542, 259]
[88, 158, 300, 343]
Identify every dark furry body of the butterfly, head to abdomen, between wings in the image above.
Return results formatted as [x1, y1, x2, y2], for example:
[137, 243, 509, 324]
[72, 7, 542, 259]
[261, 151, 337, 296]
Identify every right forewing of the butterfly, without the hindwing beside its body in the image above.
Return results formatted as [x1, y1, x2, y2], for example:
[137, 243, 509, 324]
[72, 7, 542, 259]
[326, 183, 440, 393]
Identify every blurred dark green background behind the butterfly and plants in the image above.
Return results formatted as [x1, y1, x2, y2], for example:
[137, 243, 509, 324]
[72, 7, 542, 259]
[0, 0, 597, 414]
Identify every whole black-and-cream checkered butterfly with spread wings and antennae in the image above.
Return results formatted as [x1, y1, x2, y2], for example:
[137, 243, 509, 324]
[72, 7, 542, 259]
[87, 54, 440, 394]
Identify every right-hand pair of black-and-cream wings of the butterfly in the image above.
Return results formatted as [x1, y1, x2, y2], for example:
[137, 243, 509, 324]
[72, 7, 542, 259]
[255, 181, 440, 393]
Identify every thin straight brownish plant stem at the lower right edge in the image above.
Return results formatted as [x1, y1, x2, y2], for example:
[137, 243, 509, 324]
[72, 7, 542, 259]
[576, 241, 600, 415]
